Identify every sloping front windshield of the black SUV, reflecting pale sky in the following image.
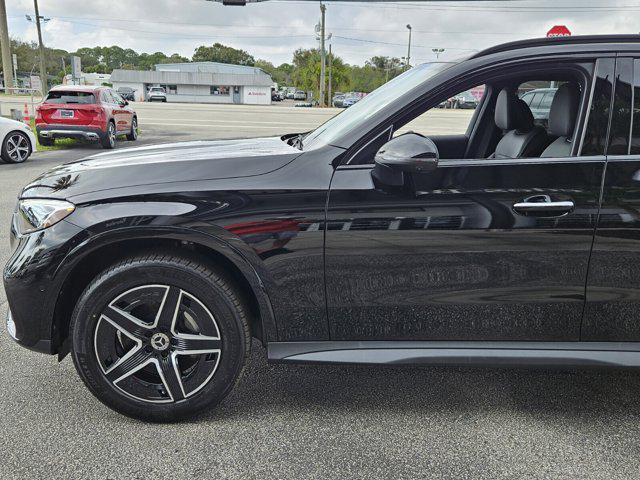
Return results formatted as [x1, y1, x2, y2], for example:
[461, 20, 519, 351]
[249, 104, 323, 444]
[304, 62, 454, 148]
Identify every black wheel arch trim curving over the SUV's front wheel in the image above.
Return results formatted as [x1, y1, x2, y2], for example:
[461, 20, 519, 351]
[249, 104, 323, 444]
[50, 228, 277, 358]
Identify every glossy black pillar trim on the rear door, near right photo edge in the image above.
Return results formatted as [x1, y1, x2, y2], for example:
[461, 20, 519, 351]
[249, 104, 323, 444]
[607, 58, 633, 155]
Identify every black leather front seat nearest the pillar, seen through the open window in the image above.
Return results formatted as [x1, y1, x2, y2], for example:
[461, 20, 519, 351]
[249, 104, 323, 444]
[541, 84, 580, 157]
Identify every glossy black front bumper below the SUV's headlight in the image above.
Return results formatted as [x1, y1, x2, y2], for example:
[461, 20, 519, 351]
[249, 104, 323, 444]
[3, 216, 89, 354]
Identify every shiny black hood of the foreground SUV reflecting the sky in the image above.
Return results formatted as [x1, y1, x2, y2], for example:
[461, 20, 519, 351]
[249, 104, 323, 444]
[21, 137, 302, 198]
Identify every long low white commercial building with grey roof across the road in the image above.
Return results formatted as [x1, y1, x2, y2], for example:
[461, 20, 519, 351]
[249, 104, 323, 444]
[111, 62, 273, 105]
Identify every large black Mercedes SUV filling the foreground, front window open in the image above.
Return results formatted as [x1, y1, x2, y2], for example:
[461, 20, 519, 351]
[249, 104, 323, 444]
[4, 36, 640, 420]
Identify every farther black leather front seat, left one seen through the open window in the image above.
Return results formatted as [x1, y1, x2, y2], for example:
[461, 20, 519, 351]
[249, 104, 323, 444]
[491, 88, 549, 158]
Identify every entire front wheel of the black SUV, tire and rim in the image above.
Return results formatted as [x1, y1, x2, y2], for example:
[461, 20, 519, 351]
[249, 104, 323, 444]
[70, 252, 251, 422]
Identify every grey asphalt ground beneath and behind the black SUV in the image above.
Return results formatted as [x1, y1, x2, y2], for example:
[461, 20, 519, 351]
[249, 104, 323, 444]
[0, 104, 640, 479]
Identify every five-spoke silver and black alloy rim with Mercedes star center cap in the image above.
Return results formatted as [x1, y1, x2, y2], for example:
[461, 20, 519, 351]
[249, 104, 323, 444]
[94, 285, 222, 403]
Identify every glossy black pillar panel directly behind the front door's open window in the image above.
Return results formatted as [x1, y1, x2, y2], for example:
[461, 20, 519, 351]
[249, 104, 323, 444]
[580, 58, 615, 156]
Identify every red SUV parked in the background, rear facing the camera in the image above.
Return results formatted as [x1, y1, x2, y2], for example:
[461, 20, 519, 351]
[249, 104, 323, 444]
[36, 85, 138, 148]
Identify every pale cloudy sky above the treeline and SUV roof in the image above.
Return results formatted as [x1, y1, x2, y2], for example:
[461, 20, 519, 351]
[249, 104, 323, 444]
[7, 0, 640, 65]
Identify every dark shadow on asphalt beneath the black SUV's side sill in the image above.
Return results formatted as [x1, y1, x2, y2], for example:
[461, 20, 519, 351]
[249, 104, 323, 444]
[200, 345, 640, 422]
